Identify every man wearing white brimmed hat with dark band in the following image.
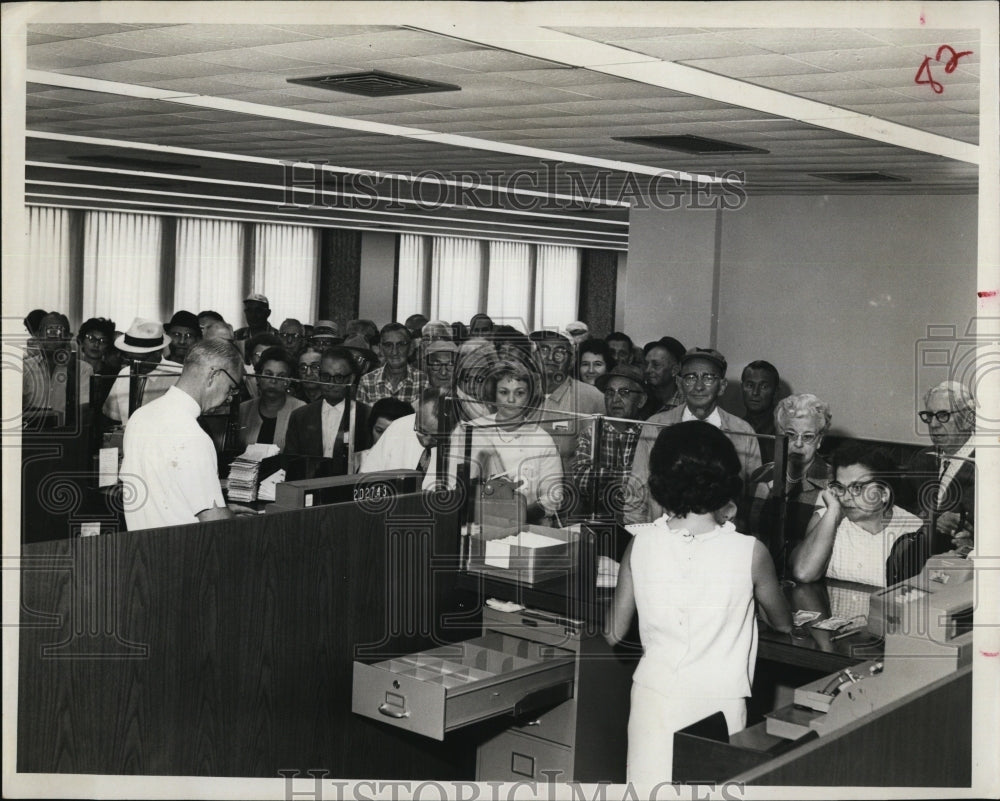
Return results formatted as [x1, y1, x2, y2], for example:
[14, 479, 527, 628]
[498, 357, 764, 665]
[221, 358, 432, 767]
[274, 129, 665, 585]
[102, 317, 183, 425]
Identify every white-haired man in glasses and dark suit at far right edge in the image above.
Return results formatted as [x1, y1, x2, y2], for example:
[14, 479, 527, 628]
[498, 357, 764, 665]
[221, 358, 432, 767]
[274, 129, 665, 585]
[907, 381, 976, 551]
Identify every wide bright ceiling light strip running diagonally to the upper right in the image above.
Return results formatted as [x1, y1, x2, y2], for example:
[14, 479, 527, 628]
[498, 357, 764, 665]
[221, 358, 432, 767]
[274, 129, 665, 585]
[404, 22, 979, 164]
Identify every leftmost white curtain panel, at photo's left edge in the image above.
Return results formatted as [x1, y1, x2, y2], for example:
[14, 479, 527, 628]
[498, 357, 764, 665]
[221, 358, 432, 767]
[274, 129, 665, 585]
[25, 206, 72, 328]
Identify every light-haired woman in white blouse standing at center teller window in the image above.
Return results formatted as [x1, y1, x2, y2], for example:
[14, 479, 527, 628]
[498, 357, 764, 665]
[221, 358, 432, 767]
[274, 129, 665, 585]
[448, 362, 563, 523]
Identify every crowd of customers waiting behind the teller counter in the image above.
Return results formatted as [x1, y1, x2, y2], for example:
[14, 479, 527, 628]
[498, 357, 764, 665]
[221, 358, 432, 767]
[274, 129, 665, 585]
[23, 293, 975, 583]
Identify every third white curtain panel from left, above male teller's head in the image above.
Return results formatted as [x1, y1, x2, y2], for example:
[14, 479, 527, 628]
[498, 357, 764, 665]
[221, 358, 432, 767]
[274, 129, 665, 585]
[174, 218, 242, 328]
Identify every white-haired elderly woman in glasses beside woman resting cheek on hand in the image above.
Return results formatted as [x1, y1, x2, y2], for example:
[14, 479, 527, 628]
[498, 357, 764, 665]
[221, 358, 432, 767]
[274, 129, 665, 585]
[750, 394, 833, 573]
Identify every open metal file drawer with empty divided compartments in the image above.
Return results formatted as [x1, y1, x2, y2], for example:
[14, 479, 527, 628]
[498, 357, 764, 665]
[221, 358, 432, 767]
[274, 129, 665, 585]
[351, 630, 576, 740]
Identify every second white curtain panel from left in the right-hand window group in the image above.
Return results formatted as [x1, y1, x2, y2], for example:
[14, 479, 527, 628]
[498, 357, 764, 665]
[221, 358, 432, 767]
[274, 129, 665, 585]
[430, 236, 483, 323]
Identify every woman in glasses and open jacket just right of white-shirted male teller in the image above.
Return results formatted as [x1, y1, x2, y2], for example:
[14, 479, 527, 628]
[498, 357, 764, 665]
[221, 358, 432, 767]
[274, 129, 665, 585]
[240, 348, 305, 449]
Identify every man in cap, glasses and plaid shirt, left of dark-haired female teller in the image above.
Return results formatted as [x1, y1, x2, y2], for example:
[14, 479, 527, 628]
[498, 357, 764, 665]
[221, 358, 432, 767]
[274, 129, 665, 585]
[571, 364, 646, 519]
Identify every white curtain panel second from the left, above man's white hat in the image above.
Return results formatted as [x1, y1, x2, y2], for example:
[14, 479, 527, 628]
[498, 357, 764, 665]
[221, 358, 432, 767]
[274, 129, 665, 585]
[83, 211, 163, 331]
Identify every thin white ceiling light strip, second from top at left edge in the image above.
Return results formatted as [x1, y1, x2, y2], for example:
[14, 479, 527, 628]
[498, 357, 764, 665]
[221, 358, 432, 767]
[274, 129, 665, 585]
[25, 130, 632, 207]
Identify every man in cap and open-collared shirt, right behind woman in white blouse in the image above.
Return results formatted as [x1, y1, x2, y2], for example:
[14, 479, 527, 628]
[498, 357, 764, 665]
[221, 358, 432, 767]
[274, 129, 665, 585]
[529, 331, 604, 473]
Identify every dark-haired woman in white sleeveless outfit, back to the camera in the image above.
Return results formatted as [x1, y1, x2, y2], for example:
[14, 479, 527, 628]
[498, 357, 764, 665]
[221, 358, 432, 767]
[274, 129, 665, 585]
[606, 421, 792, 784]
